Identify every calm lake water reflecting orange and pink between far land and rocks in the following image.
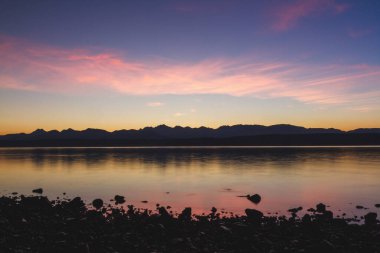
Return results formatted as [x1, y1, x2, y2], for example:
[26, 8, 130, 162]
[0, 147, 380, 216]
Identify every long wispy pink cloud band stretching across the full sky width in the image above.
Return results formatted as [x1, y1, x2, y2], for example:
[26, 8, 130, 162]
[0, 34, 380, 107]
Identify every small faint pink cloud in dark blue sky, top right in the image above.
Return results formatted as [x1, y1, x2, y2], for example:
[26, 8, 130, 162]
[272, 0, 348, 31]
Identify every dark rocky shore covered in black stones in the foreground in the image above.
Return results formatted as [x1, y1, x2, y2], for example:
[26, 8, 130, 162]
[0, 193, 380, 253]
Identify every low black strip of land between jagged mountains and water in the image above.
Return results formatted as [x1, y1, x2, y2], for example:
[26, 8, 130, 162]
[0, 133, 380, 147]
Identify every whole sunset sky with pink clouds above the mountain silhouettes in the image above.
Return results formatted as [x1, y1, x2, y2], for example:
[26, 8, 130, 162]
[0, 0, 380, 134]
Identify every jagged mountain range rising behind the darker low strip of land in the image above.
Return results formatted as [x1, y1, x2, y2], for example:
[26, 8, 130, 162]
[0, 124, 380, 141]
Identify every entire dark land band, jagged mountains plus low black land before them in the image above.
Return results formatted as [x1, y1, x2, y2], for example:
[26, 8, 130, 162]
[0, 124, 380, 146]
